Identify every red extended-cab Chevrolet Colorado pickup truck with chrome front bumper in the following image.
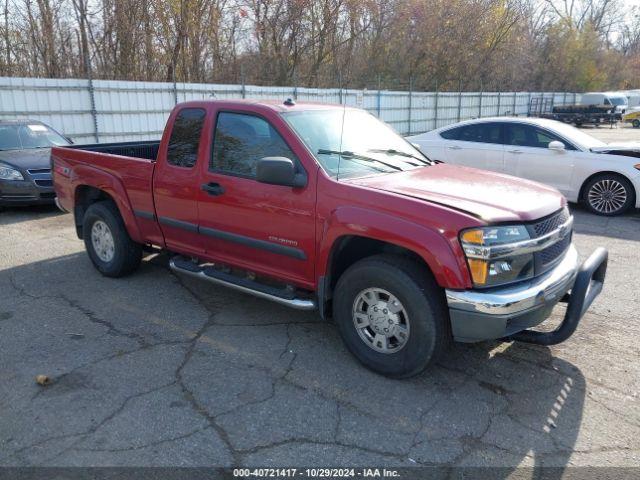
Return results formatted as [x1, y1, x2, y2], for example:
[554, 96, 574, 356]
[51, 100, 607, 377]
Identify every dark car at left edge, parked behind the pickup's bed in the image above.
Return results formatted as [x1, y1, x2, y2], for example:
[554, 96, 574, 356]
[0, 120, 71, 208]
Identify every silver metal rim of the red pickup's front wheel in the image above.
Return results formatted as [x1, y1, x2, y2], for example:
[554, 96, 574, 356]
[352, 288, 409, 353]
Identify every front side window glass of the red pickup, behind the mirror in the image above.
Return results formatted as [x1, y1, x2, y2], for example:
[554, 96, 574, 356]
[209, 112, 296, 177]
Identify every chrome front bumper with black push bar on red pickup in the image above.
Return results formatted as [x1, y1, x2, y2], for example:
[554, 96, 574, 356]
[446, 245, 607, 345]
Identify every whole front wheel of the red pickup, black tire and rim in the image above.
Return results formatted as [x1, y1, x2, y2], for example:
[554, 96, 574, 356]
[334, 255, 451, 378]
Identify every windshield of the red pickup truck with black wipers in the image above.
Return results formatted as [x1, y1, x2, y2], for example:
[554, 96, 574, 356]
[282, 108, 431, 178]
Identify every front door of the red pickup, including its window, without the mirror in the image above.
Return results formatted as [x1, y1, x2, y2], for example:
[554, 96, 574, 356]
[198, 111, 315, 286]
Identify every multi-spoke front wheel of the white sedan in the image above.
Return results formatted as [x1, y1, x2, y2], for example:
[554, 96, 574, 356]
[583, 173, 635, 216]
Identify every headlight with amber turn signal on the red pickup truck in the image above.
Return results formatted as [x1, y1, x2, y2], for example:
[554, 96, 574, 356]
[460, 225, 534, 287]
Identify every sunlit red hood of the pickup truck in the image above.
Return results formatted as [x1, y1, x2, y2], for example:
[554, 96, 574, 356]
[349, 164, 566, 223]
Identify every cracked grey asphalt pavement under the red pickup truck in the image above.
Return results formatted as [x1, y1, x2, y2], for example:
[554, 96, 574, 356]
[0, 202, 640, 467]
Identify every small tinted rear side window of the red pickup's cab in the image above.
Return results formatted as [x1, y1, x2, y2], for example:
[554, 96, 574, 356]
[167, 108, 205, 168]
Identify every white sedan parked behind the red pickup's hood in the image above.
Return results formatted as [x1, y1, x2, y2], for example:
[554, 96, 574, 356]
[407, 117, 640, 215]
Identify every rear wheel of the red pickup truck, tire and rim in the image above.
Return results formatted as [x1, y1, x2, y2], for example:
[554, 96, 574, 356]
[82, 201, 142, 277]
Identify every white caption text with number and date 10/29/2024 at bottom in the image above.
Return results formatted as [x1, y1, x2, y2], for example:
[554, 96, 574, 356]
[233, 468, 400, 478]
